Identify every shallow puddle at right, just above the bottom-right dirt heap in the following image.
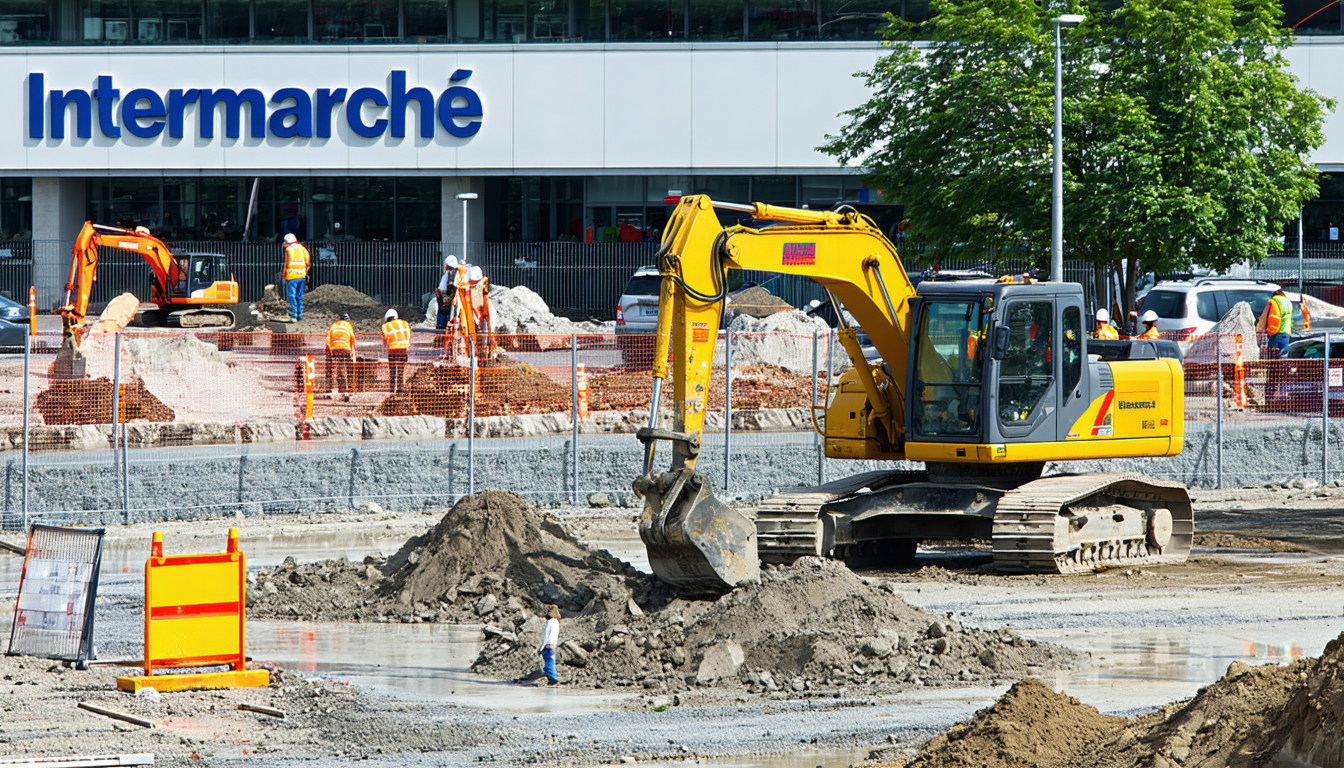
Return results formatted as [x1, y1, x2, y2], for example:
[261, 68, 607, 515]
[1023, 620, 1339, 713]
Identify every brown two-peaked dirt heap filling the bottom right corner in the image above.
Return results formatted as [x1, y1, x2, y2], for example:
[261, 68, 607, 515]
[864, 636, 1344, 768]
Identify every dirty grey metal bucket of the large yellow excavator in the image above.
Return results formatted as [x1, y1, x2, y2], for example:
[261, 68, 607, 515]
[637, 468, 761, 597]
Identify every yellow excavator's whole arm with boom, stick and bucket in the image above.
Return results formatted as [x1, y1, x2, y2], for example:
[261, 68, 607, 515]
[634, 195, 915, 594]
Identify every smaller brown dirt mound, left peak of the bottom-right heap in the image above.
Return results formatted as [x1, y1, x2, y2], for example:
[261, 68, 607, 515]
[910, 678, 1129, 768]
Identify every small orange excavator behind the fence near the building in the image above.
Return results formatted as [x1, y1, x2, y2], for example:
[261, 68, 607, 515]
[54, 222, 238, 378]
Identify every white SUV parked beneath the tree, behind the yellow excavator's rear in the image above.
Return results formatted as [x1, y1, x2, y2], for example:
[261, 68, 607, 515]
[1138, 277, 1310, 342]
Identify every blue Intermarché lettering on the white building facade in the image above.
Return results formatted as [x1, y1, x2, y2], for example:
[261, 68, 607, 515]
[28, 70, 484, 139]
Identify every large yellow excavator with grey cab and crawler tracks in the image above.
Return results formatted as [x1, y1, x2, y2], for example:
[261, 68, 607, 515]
[633, 195, 1193, 597]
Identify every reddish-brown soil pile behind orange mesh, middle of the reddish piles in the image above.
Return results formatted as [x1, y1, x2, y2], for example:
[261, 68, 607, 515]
[374, 356, 572, 418]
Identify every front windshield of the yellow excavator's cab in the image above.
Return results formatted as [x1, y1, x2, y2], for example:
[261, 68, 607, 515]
[915, 301, 985, 436]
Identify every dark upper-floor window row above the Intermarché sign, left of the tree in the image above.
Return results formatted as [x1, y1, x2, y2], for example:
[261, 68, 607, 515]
[0, 0, 929, 44]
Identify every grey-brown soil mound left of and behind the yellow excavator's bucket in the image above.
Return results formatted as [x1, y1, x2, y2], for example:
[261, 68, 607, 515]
[247, 491, 668, 624]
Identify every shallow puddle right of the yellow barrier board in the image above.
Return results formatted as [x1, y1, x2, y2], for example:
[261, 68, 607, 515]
[247, 620, 632, 713]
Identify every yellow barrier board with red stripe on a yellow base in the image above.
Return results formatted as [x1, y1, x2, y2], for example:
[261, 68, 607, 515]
[117, 529, 270, 691]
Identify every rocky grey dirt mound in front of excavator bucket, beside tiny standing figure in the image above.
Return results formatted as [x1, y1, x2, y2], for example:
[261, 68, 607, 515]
[473, 558, 1073, 693]
